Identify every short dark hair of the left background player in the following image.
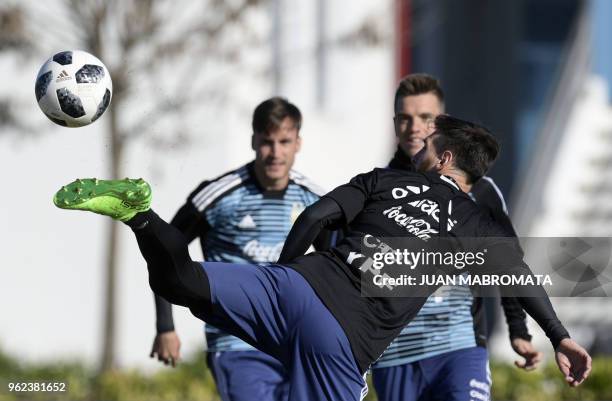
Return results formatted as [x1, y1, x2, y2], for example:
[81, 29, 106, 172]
[252, 96, 302, 134]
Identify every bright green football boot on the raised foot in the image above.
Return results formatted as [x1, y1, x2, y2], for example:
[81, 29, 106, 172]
[53, 178, 151, 221]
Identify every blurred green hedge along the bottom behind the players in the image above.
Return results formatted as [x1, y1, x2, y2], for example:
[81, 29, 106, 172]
[0, 346, 612, 401]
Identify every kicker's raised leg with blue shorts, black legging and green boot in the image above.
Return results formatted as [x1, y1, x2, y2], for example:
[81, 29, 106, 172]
[54, 180, 365, 401]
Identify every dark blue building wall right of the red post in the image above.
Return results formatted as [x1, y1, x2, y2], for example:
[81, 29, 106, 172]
[411, 0, 580, 195]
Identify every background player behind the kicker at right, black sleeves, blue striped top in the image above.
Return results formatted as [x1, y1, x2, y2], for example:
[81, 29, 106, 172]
[373, 74, 542, 401]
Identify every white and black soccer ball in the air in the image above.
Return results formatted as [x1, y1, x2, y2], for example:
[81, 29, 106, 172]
[34, 50, 113, 127]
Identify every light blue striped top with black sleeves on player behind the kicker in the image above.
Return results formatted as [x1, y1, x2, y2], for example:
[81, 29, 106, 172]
[372, 147, 530, 368]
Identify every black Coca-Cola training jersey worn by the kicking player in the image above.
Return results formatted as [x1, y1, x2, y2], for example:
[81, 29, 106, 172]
[288, 169, 567, 371]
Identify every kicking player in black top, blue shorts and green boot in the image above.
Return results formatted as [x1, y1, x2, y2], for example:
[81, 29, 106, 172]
[54, 116, 591, 401]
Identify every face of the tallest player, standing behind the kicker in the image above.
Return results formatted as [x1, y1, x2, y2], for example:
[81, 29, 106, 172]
[394, 92, 444, 157]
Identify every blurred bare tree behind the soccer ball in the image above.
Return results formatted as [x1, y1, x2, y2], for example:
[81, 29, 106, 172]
[0, 0, 264, 371]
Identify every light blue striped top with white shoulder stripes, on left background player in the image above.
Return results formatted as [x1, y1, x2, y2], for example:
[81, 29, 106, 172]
[187, 162, 322, 352]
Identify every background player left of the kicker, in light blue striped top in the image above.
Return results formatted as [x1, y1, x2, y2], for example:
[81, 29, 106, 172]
[151, 97, 329, 401]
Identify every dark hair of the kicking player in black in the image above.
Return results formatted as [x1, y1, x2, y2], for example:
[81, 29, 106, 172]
[432, 114, 499, 183]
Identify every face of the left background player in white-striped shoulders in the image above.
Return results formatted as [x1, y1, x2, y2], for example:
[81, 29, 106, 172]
[252, 117, 301, 182]
